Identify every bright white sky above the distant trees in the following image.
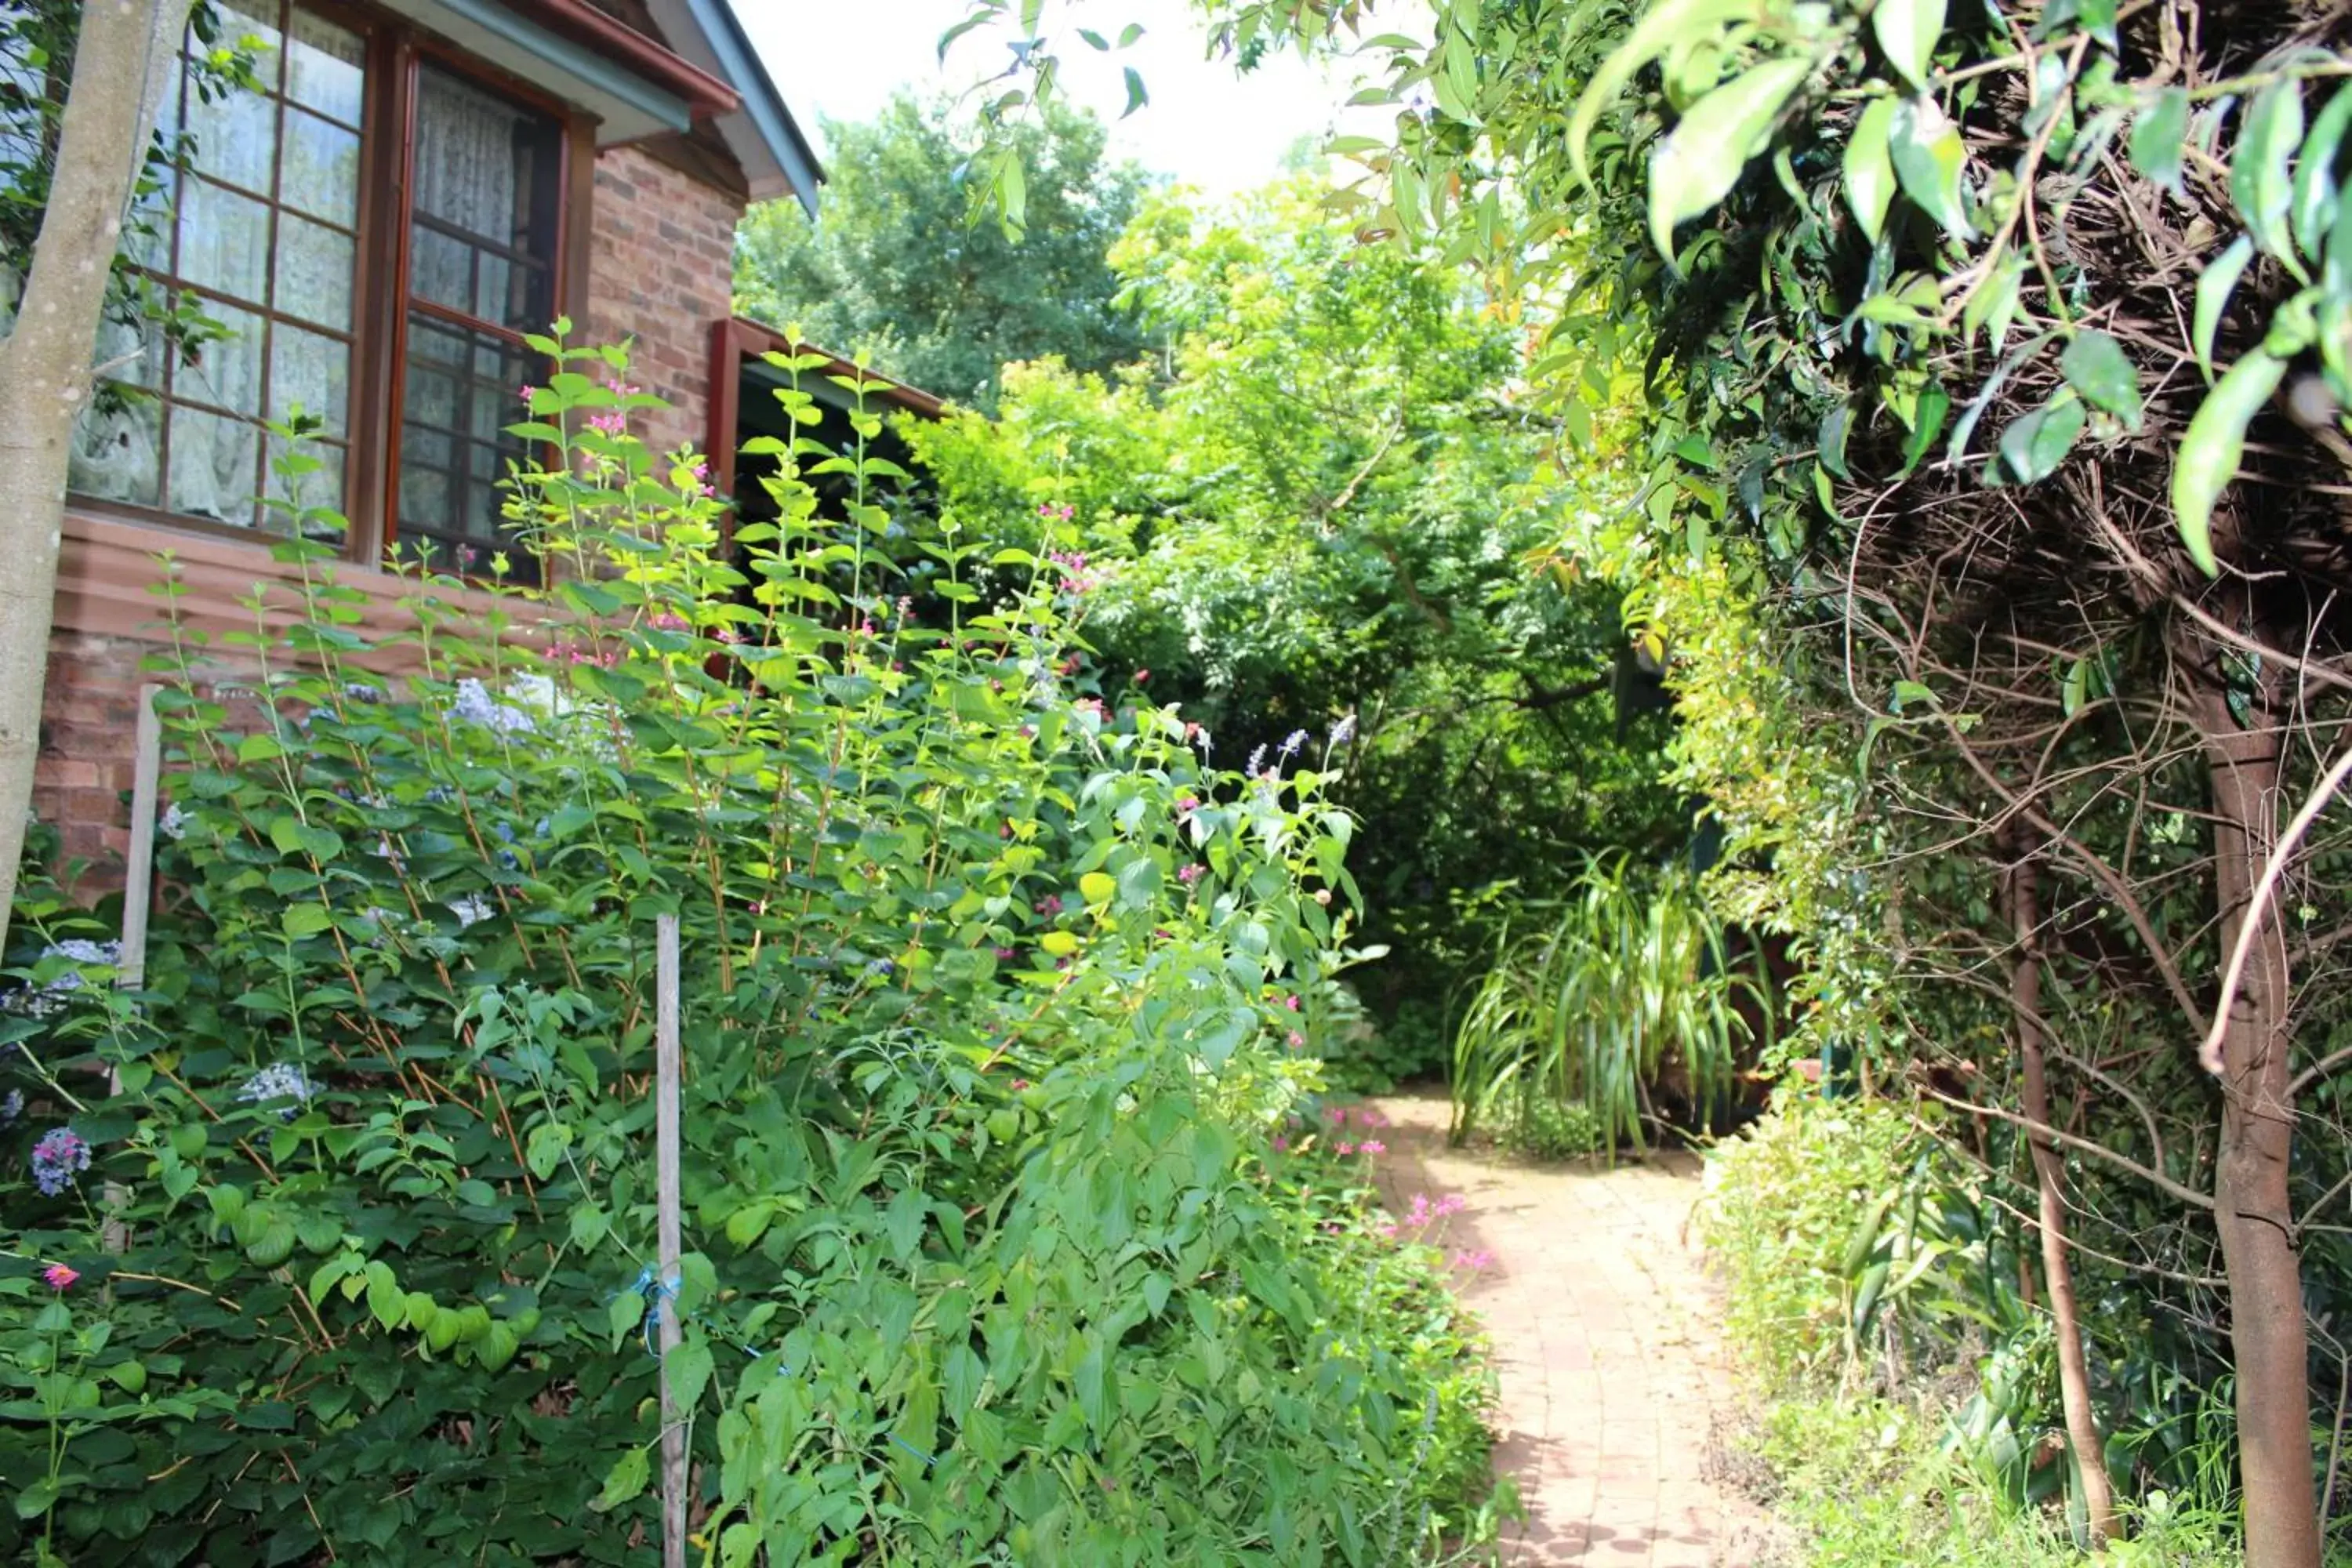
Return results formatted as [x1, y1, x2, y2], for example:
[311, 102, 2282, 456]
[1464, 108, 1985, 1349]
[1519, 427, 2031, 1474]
[734, 0, 1388, 195]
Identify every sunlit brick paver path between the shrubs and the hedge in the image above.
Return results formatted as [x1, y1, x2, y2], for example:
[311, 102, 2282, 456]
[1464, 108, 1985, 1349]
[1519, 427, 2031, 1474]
[1378, 1095, 1759, 1568]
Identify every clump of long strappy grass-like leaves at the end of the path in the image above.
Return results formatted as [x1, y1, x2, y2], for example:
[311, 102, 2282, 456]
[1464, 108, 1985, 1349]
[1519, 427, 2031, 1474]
[1454, 858, 1748, 1147]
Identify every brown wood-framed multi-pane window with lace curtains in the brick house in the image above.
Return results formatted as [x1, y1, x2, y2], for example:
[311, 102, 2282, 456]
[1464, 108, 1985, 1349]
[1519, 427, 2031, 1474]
[71, 0, 576, 569]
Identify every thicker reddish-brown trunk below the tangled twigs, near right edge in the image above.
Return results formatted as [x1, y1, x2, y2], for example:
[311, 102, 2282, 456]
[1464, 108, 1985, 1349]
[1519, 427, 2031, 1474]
[2194, 682, 2319, 1568]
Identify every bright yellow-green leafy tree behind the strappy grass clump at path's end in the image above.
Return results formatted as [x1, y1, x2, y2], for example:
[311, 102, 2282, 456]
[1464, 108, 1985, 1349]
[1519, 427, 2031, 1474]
[908, 179, 1684, 1083]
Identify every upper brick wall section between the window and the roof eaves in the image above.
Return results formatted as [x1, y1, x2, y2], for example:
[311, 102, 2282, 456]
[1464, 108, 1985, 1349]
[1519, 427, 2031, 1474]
[588, 148, 743, 452]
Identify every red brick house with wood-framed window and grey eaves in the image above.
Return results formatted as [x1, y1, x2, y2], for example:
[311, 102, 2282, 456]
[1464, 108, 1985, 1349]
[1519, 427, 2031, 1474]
[35, 0, 823, 877]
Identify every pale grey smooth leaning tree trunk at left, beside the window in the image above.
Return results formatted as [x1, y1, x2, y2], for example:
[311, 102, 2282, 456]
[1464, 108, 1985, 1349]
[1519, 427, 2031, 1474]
[0, 0, 191, 945]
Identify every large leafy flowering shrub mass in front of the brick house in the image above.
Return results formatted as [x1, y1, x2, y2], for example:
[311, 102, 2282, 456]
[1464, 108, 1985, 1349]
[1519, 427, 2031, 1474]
[0, 341, 1486, 1566]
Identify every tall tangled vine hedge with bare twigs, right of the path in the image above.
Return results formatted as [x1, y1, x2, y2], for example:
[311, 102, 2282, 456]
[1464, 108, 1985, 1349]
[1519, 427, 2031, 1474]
[946, 0, 2352, 1568]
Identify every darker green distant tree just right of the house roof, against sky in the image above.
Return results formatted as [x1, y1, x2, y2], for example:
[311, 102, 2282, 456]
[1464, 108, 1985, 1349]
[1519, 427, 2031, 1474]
[736, 94, 1150, 409]
